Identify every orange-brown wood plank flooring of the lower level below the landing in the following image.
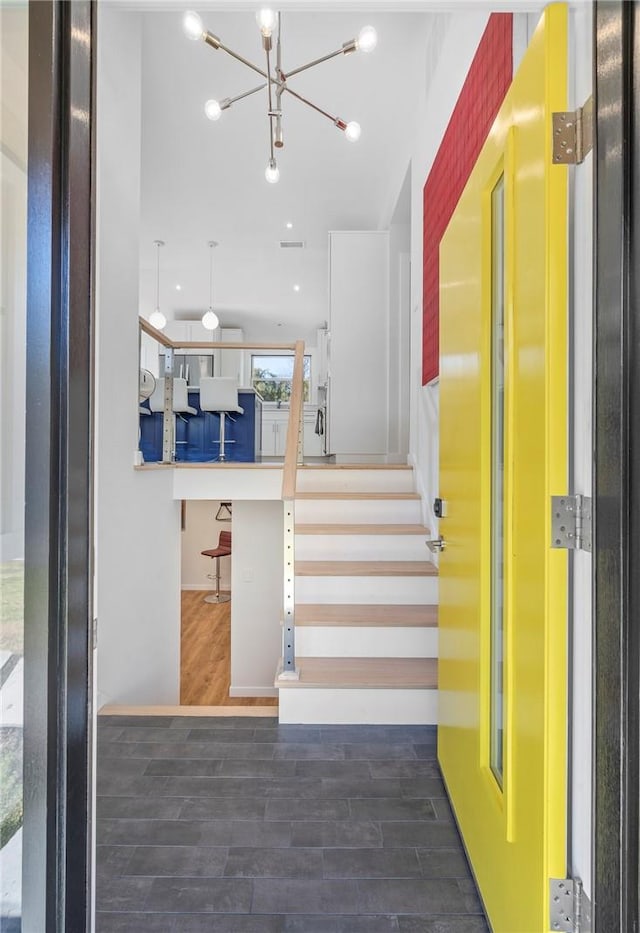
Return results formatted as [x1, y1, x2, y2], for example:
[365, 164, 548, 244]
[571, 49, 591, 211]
[180, 590, 278, 706]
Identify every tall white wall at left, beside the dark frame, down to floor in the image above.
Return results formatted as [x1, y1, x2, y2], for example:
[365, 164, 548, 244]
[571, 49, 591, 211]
[96, 4, 180, 705]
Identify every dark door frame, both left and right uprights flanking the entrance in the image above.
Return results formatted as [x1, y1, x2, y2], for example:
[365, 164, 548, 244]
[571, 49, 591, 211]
[15, 0, 640, 933]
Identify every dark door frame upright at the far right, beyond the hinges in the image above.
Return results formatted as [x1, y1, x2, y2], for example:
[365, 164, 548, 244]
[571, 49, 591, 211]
[585, 0, 640, 933]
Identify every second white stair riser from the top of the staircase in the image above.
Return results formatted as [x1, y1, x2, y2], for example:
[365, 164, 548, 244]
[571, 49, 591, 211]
[295, 499, 422, 525]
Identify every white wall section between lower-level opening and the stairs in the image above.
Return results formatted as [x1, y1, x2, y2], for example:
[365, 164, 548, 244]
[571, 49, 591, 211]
[229, 501, 284, 696]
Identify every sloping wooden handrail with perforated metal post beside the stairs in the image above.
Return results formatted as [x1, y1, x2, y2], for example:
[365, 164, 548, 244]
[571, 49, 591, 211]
[278, 340, 304, 680]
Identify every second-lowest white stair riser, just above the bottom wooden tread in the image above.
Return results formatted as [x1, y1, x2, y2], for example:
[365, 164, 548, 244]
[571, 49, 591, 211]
[296, 625, 438, 658]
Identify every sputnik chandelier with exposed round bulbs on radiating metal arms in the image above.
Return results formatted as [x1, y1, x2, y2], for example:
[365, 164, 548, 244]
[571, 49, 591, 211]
[183, 9, 378, 184]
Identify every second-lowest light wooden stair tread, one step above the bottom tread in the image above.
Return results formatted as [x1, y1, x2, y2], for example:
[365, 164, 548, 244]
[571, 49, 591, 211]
[296, 603, 438, 628]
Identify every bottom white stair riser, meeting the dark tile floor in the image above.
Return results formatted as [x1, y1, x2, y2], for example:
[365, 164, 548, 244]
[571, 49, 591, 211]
[278, 685, 438, 725]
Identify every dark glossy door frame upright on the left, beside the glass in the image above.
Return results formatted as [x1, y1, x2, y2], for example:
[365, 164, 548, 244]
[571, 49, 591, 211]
[22, 0, 95, 933]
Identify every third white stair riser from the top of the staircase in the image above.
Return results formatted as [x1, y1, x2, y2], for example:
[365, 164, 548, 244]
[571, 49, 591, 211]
[296, 533, 430, 560]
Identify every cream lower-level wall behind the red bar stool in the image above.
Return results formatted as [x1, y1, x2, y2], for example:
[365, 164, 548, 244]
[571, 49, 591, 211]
[180, 499, 232, 590]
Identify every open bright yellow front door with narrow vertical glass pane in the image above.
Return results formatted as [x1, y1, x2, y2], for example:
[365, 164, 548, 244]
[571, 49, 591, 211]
[438, 5, 567, 933]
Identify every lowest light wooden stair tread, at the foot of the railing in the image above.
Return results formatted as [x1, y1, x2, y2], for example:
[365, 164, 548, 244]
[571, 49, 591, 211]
[276, 658, 438, 690]
